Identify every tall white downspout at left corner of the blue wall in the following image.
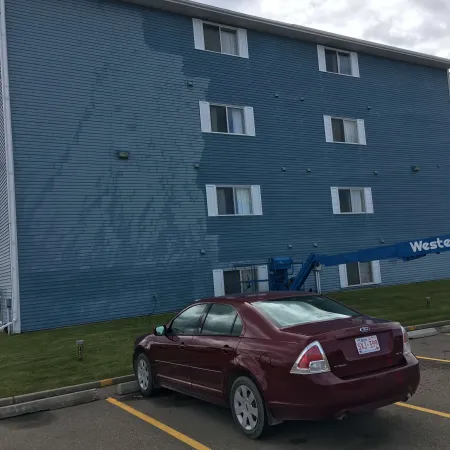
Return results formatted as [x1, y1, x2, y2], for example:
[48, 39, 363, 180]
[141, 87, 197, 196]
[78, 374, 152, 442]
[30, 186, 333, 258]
[0, 0, 21, 334]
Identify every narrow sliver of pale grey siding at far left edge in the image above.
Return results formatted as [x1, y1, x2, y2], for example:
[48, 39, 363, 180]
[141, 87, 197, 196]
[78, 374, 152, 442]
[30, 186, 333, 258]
[0, 10, 11, 323]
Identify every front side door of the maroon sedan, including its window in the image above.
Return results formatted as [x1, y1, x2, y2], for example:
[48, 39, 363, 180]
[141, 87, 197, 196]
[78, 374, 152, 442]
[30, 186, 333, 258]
[150, 304, 207, 390]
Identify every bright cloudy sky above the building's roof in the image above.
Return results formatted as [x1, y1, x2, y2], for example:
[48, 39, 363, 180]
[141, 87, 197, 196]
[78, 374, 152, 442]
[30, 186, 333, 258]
[196, 0, 450, 58]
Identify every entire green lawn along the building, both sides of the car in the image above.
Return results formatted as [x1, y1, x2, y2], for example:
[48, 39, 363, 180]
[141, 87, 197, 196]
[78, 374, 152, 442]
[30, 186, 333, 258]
[0, 280, 450, 398]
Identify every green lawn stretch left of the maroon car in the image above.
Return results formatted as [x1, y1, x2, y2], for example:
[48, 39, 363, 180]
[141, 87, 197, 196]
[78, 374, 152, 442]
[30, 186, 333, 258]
[0, 314, 172, 398]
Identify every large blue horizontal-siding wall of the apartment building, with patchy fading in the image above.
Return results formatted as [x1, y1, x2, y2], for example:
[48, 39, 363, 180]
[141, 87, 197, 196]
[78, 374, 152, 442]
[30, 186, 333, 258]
[7, 0, 450, 331]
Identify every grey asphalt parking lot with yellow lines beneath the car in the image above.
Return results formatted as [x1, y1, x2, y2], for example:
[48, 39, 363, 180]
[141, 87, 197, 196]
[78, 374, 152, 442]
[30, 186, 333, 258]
[0, 334, 450, 450]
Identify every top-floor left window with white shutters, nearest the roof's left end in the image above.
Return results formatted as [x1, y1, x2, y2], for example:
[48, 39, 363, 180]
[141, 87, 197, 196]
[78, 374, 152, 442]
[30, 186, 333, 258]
[192, 19, 248, 58]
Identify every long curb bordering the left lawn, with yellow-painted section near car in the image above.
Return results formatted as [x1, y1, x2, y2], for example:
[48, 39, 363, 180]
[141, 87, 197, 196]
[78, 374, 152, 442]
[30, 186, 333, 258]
[0, 375, 136, 407]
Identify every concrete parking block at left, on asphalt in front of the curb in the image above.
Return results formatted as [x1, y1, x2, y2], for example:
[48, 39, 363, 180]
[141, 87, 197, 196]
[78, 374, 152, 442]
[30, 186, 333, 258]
[0, 389, 100, 419]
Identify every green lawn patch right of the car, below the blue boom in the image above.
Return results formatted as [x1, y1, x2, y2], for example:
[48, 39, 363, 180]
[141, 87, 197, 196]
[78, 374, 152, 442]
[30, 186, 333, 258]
[331, 280, 450, 326]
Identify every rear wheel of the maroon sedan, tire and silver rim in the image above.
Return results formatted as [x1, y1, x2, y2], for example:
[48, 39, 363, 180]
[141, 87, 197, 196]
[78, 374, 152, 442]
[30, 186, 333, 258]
[230, 377, 269, 439]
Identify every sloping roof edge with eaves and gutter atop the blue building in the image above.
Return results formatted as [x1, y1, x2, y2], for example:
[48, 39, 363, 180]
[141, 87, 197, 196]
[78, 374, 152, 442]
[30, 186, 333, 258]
[122, 0, 450, 69]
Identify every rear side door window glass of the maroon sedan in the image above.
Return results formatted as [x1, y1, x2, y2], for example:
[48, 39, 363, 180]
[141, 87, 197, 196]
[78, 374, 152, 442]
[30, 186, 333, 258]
[201, 303, 242, 336]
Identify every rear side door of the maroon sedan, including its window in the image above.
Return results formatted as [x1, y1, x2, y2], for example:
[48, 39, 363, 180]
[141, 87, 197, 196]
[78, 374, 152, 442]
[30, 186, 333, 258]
[190, 303, 242, 400]
